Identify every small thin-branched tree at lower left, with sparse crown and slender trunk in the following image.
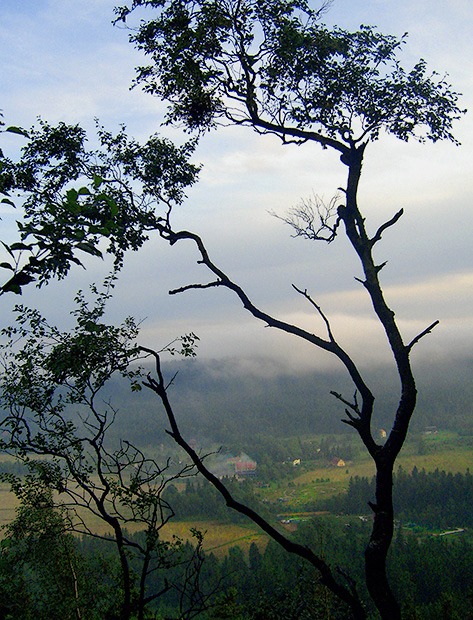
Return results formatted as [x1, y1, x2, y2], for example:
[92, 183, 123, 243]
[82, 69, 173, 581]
[0, 274, 202, 620]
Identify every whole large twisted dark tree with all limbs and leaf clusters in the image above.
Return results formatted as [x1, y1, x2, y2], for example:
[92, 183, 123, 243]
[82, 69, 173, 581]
[0, 0, 463, 619]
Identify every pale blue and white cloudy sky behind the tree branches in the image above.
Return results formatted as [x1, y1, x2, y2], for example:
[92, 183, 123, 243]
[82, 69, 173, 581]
[0, 0, 473, 373]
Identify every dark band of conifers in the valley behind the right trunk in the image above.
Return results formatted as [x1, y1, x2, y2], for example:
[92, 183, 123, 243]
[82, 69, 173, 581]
[323, 467, 473, 528]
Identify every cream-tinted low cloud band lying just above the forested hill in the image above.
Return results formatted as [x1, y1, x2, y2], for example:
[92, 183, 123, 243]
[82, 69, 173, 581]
[126, 264, 473, 372]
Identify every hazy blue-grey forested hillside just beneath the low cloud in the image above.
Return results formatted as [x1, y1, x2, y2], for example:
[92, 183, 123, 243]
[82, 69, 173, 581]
[98, 359, 473, 445]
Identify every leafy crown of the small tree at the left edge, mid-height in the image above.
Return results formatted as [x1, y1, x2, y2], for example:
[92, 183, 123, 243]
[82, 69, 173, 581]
[1, 274, 141, 402]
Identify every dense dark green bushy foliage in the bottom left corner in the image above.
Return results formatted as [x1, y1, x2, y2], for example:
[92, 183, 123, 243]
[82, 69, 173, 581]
[0, 475, 220, 620]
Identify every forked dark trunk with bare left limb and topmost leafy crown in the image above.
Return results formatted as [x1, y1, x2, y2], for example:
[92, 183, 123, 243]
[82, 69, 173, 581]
[112, 0, 463, 619]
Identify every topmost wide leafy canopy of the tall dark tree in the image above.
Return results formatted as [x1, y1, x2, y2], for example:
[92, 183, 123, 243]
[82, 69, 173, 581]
[116, 0, 461, 145]
